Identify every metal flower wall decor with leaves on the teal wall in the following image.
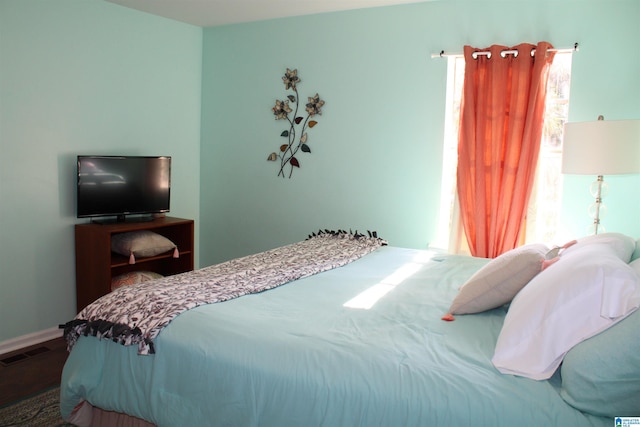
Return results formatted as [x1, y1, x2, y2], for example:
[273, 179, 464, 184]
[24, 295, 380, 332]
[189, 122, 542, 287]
[267, 68, 324, 178]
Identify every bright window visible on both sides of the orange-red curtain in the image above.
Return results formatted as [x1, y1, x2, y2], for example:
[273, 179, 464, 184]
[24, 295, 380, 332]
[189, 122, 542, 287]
[432, 52, 572, 249]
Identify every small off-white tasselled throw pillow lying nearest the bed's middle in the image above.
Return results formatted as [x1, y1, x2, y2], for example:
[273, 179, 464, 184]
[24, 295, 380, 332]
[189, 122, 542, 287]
[449, 243, 549, 314]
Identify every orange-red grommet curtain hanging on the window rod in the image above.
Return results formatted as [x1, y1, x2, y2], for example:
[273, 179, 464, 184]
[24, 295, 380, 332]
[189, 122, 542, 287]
[457, 42, 554, 258]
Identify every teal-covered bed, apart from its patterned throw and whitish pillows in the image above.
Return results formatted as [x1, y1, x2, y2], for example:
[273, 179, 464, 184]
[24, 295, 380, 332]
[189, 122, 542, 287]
[61, 233, 640, 427]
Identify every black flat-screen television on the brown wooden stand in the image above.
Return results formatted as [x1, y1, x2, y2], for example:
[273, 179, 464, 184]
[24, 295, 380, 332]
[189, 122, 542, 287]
[76, 156, 171, 221]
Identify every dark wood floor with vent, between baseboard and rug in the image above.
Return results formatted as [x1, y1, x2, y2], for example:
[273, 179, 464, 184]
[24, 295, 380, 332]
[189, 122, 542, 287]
[0, 338, 68, 406]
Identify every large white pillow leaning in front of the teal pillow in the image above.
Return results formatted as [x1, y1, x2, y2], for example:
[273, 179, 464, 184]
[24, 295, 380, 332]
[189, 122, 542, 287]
[492, 244, 640, 380]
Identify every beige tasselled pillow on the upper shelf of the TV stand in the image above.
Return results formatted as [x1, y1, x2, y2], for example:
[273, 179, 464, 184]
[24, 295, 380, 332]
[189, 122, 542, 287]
[111, 230, 180, 264]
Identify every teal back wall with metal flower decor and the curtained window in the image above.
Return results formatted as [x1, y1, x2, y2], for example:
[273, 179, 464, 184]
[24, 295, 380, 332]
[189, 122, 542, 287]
[200, 0, 640, 264]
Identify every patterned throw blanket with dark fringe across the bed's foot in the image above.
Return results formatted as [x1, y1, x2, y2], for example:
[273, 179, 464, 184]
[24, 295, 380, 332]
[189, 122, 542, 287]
[60, 230, 386, 354]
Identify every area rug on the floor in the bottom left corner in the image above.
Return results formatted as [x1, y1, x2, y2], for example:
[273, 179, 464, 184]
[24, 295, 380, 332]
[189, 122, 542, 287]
[0, 387, 73, 427]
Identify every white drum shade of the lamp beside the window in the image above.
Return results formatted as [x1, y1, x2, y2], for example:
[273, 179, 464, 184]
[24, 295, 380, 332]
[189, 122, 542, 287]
[562, 120, 640, 175]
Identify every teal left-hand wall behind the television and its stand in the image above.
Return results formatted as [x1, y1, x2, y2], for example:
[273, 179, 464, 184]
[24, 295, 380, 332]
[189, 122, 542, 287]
[0, 0, 202, 342]
